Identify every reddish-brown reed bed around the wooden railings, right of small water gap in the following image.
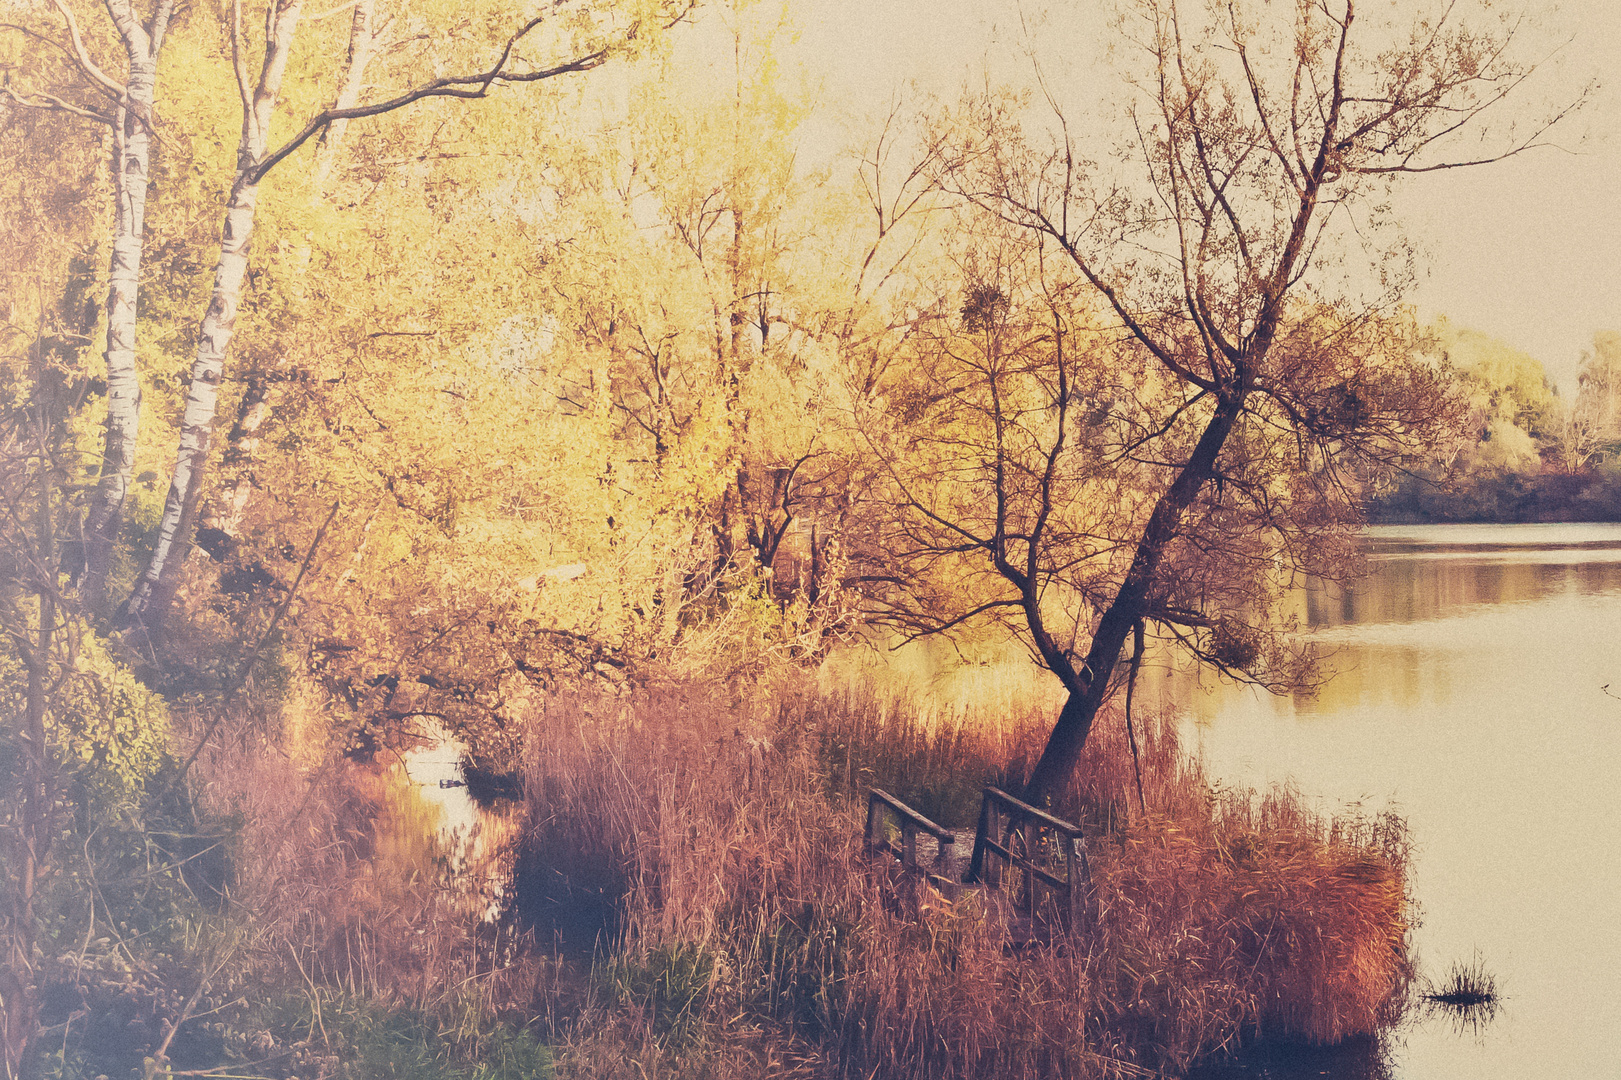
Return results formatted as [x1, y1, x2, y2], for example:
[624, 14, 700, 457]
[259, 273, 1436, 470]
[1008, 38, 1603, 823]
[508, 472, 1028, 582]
[519, 684, 1407, 1078]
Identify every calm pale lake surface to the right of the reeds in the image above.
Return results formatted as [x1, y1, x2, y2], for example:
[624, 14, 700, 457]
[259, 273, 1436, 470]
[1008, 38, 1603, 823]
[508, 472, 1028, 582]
[1159, 525, 1621, 1080]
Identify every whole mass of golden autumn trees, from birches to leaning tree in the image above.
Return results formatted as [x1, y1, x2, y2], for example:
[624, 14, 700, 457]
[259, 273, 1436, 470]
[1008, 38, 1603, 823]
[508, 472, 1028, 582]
[0, 0, 1588, 947]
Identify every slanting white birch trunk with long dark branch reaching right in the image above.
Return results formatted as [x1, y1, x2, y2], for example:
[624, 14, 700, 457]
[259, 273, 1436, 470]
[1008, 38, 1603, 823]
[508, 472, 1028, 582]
[125, 0, 300, 634]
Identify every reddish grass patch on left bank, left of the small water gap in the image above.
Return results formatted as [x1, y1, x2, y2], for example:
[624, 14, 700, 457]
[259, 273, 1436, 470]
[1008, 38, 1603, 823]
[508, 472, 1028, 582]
[181, 707, 546, 1057]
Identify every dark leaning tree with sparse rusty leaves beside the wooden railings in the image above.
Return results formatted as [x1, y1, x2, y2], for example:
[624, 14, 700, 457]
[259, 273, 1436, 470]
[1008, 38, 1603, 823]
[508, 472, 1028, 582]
[880, 0, 1579, 799]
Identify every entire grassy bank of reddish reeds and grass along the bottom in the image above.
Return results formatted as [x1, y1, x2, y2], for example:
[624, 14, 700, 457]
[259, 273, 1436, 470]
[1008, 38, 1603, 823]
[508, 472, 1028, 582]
[32, 681, 1409, 1080]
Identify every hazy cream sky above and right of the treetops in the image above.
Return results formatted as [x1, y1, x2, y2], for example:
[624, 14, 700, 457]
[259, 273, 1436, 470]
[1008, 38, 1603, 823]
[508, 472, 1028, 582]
[789, 0, 1621, 394]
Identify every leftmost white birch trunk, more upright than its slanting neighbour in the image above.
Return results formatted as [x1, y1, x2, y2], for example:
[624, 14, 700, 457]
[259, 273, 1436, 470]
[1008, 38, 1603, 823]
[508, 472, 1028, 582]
[83, 0, 173, 610]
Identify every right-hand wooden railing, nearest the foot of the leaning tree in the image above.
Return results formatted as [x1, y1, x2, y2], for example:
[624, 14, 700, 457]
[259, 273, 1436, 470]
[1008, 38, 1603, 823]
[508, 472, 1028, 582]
[966, 786, 1093, 931]
